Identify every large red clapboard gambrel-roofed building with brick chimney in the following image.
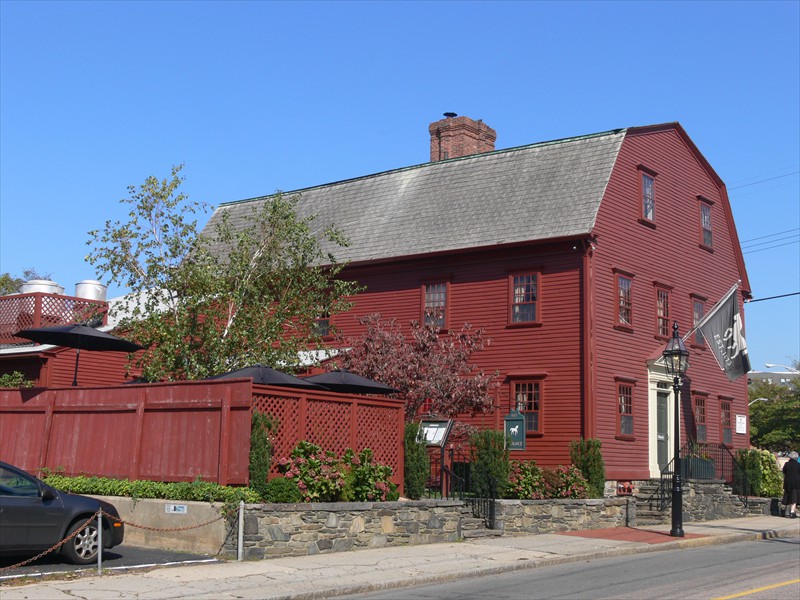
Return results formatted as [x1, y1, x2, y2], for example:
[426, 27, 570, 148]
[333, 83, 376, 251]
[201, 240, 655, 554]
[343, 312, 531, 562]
[208, 115, 750, 479]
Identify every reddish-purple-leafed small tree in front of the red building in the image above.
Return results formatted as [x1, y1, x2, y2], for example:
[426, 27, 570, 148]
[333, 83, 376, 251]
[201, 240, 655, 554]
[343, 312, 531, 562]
[339, 314, 497, 421]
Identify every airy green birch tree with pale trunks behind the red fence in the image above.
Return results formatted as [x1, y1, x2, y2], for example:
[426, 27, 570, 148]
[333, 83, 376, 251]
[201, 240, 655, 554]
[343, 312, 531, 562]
[87, 165, 358, 380]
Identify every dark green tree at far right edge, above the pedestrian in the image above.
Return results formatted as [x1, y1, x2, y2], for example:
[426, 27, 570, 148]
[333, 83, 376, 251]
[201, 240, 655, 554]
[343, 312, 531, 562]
[748, 383, 800, 452]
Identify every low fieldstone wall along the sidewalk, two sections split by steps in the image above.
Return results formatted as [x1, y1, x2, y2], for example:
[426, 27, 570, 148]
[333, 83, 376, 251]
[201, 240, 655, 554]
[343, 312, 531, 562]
[223, 498, 636, 559]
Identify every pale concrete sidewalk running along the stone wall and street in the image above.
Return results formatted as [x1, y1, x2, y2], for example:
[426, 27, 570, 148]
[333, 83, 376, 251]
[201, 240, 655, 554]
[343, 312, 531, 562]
[0, 516, 800, 600]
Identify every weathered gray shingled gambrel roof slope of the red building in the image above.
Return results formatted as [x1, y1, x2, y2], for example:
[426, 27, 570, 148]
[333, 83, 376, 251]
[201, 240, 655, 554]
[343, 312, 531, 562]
[204, 129, 625, 262]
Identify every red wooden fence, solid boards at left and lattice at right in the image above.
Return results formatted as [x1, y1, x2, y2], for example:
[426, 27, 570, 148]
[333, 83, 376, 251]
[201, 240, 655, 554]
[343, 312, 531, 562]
[0, 379, 403, 491]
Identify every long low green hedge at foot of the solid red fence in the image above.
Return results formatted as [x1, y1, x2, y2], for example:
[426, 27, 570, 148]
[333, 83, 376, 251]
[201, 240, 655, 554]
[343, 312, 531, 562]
[43, 475, 261, 503]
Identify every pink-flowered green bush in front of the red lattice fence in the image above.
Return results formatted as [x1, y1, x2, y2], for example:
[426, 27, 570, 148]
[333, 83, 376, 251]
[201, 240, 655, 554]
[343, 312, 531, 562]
[278, 442, 397, 502]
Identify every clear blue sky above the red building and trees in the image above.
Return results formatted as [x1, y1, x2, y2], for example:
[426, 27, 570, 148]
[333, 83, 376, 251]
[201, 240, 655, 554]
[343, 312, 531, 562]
[0, 0, 800, 369]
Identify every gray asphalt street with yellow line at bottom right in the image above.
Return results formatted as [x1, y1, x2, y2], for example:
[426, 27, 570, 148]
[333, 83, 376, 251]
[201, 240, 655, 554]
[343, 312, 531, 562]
[343, 536, 800, 600]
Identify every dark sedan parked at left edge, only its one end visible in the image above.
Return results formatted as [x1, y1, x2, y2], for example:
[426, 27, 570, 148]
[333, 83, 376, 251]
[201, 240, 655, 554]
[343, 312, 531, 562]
[0, 461, 125, 564]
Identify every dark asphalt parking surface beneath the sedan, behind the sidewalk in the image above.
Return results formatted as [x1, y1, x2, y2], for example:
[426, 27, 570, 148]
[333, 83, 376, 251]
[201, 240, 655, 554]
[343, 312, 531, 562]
[0, 544, 218, 581]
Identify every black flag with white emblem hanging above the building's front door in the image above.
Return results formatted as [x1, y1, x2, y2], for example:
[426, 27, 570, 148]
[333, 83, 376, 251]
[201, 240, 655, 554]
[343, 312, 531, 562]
[697, 286, 750, 381]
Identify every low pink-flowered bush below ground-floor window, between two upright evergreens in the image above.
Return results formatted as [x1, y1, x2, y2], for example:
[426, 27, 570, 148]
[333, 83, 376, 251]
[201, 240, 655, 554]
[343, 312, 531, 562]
[507, 460, 589, 500]
